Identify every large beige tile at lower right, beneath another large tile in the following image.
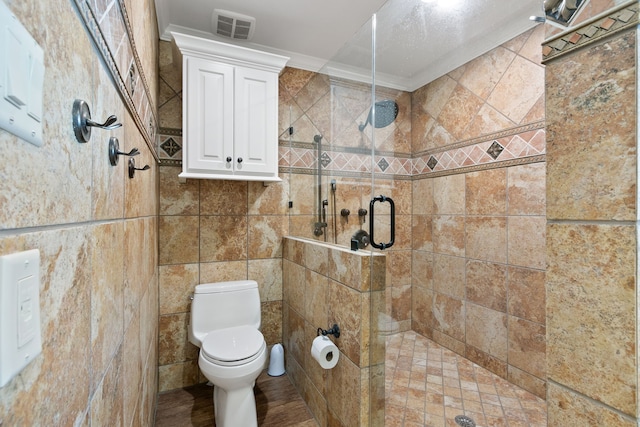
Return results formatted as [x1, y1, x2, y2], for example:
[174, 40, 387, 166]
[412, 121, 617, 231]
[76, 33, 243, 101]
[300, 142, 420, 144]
[546, 224, 636, 413]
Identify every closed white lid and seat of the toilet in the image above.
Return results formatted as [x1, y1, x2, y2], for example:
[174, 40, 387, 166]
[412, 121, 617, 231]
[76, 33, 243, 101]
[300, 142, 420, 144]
[201, 325, 267, 366]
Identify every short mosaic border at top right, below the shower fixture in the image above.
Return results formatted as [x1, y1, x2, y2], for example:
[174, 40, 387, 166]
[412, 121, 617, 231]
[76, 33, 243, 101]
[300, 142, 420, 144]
[542, 0, 640, 64]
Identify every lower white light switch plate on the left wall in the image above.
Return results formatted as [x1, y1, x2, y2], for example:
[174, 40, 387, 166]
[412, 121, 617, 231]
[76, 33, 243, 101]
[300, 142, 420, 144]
[0, 249, 42, 387]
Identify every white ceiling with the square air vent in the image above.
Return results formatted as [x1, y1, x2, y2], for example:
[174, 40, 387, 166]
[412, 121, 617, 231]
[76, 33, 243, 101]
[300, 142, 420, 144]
[155, 0, 542, 91]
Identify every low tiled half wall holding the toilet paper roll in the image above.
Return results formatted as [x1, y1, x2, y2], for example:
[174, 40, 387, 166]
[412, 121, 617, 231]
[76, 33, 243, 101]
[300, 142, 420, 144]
[282, 238, 385, 427]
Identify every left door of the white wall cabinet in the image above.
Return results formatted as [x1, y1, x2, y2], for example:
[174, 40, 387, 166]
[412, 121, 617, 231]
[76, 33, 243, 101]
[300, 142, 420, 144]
[183, 58, 234, 175]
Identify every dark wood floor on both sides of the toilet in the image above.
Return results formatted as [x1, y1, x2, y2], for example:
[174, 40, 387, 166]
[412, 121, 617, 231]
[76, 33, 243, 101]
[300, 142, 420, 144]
[155, 372, 317, 427]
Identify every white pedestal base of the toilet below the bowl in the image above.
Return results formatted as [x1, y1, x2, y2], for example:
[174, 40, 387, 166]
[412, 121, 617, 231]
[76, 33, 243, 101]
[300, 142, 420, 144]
[213, 383, 258, 427]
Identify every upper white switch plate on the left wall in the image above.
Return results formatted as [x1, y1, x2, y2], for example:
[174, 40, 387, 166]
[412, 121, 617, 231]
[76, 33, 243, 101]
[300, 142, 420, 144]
[0, 1, 45, 147]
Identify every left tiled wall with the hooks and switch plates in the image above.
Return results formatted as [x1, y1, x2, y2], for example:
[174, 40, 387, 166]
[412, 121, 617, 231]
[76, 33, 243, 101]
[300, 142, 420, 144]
[0, 0, 158, 426]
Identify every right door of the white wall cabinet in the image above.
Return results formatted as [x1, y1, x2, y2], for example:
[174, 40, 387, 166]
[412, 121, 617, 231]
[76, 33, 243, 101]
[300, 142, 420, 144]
[234, 67, 278, 177]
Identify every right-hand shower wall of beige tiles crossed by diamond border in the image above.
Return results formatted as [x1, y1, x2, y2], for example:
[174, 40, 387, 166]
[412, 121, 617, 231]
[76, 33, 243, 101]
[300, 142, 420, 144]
[411, 26, 546, 397]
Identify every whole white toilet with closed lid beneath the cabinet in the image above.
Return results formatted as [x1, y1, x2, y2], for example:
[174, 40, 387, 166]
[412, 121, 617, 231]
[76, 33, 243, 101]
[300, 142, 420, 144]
[189, 280, 267, 427]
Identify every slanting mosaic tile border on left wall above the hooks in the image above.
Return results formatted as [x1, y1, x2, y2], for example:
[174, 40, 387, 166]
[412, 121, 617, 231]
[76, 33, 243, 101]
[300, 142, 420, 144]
[74, 0, 159, 161]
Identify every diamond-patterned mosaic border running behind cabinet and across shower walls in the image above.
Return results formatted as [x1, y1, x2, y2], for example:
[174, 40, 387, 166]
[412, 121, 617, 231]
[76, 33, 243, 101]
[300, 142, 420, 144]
[158, 121, 546, 180]
